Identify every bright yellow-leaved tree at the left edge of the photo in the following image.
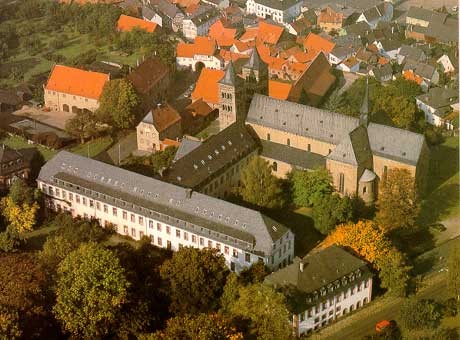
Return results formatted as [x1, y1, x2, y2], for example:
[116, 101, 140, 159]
[0, 197, 39, 234]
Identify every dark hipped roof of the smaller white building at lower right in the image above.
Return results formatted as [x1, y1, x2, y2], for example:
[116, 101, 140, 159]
[265, 245, 369, 294]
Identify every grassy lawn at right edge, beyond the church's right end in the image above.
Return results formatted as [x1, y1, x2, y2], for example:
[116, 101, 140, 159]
[420, 137, 460, 224]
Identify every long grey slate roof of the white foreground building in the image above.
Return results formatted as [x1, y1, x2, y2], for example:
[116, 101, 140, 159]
[38, 151, 288, 255]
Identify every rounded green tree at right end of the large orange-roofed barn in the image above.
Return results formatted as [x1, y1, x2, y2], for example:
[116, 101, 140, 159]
[96, 79, 139, 129]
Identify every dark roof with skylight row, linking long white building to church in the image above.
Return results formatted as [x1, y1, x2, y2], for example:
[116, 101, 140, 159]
[164, 123, 257, 190]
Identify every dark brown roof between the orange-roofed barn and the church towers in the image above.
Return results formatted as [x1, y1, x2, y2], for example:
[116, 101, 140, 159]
[127, 58, 169, 94]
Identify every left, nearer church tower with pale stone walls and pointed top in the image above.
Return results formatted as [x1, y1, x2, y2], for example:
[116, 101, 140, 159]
[218, 62, 240, 130]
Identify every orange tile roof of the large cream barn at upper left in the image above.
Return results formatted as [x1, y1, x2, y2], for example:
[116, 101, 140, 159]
[45, 65, 110, 99]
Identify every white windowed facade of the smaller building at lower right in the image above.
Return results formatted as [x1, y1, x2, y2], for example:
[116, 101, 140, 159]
[293, 278, 372, 336]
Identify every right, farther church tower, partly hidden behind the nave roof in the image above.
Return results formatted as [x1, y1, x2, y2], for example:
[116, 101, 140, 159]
[241, 47, 268, 115]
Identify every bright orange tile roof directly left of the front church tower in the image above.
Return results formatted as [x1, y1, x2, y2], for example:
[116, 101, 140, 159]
[192, 68, 225, 104]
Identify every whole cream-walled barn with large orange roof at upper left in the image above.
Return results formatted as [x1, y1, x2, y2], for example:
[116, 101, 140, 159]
[44, 65, 110, 113]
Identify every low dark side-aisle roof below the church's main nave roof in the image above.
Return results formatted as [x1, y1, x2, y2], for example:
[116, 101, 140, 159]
[260, 140, 326, 170]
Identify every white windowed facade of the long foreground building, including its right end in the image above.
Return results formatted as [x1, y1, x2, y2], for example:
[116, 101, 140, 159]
[37, 180, 294, 273]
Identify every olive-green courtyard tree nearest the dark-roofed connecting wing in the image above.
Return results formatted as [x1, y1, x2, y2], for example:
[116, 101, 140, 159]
[238, 157, 286, 208]
